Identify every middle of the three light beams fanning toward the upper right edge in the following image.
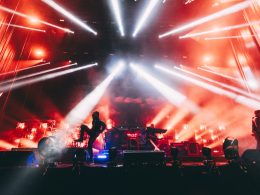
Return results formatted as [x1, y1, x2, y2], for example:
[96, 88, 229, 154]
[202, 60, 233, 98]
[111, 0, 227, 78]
[179, 21, 260, 39]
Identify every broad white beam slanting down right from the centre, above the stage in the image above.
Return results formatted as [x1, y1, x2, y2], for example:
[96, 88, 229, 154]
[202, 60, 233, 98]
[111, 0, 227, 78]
[130, 63, 199, 113]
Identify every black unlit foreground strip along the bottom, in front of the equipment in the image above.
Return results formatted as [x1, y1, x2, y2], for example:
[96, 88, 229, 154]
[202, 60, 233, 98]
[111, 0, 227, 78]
[0, 163, 260, 195]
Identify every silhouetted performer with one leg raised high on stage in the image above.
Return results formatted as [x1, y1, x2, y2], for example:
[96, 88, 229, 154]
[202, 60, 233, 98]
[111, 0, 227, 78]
[75, 111, 106, 161]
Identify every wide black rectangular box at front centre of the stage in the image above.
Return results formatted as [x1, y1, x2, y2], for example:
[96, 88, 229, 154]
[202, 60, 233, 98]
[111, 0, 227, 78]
[123, 150, 165, 167]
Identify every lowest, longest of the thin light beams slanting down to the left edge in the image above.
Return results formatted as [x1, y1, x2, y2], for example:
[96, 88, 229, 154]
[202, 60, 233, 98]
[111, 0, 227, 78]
[0, 63, 97, 92]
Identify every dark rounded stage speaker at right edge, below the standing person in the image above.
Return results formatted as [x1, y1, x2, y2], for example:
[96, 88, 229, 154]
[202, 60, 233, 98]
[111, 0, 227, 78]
[241, 149, 260, 167]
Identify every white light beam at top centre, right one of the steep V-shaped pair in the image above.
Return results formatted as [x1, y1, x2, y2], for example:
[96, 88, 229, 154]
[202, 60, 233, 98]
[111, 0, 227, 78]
[133, 0, 160, 37]
